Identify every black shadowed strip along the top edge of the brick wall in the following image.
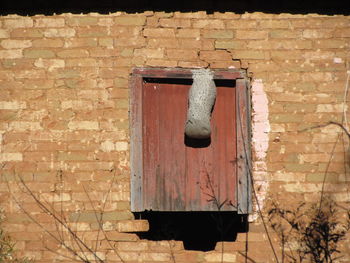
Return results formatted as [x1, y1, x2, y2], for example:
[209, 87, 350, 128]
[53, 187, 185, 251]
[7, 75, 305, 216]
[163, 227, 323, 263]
[0, 0, 350, 15]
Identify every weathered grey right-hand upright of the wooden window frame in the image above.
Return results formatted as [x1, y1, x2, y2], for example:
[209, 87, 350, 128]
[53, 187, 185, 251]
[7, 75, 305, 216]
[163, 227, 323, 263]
[236, 79, 252, 214]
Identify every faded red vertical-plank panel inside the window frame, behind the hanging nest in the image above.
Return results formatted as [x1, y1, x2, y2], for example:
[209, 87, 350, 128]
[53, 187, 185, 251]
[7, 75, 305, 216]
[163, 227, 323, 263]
[142, 81, 237, 211]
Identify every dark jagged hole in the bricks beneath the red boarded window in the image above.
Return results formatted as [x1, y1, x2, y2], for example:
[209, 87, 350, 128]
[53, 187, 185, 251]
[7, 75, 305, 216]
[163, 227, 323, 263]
[134, 211, 248, 251]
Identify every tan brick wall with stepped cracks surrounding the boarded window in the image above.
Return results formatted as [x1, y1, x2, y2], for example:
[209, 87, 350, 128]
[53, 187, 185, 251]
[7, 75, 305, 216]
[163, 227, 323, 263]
[0, 11, 350, 263]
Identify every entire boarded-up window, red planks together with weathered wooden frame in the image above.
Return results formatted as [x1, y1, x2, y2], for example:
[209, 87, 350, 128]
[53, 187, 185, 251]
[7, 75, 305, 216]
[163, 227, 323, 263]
[130, 69, 251, 213]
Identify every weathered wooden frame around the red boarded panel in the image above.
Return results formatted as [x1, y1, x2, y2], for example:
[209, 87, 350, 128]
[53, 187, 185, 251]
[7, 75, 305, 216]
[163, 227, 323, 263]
[129, 68, 252, 214]
